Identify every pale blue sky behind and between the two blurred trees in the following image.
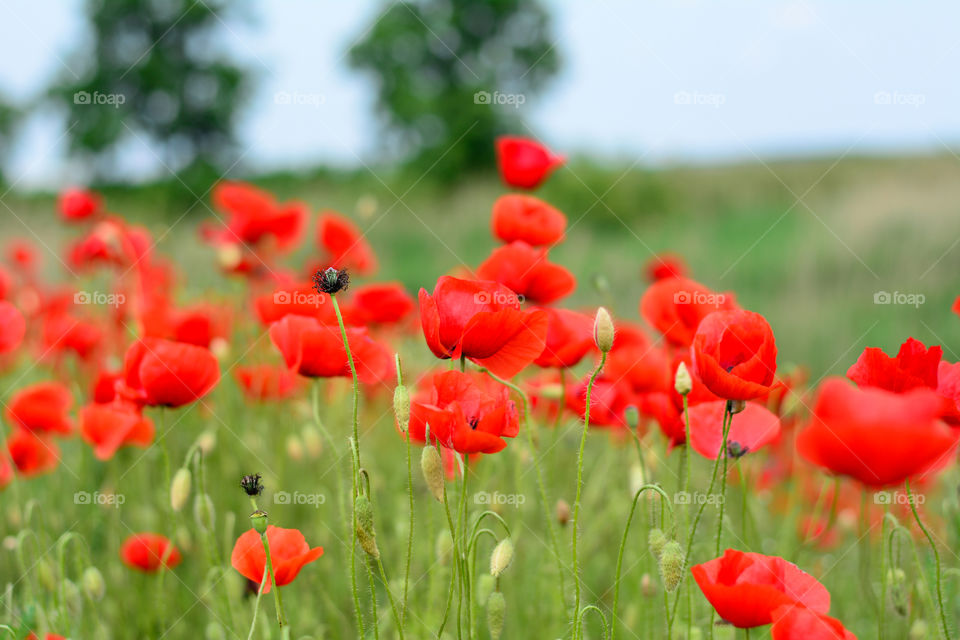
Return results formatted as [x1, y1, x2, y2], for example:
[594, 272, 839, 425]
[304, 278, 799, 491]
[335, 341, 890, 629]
[0, 0, 960, 186]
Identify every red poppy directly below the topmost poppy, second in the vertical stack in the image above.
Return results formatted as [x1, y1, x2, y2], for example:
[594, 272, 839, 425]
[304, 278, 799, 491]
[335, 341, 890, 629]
[490, 193, 567, 247]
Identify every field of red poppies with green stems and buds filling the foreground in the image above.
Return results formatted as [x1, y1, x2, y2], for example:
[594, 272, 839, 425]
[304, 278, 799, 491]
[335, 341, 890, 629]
[0, 137, 960, 640]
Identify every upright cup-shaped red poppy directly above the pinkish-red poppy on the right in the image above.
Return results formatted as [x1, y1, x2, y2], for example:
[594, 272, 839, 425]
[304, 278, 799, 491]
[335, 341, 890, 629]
[690, 309, 777, 400]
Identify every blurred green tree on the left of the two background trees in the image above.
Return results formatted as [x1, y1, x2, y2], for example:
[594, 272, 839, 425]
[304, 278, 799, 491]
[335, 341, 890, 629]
[51, 0, 248, 195]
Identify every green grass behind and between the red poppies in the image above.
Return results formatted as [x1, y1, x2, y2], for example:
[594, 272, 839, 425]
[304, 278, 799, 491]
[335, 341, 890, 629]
[0, 152, 960, 640]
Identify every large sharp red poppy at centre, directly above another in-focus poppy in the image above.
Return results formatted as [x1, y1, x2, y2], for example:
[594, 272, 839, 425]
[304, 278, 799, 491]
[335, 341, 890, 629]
[420, 276, 549, 377]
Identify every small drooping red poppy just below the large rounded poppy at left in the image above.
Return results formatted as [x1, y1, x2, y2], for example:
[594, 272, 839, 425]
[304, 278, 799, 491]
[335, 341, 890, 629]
[80, 400, 154, 460]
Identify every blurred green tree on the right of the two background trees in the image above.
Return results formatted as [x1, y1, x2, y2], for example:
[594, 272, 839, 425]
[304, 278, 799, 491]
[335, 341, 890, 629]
[349, 0, 559, 179]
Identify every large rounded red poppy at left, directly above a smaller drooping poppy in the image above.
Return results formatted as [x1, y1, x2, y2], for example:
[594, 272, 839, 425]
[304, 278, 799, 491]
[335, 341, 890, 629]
[123, 338, 220, 407]
